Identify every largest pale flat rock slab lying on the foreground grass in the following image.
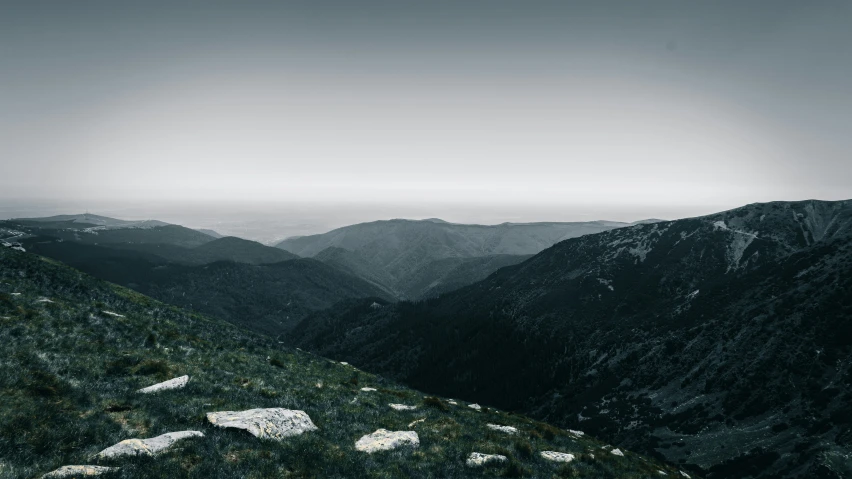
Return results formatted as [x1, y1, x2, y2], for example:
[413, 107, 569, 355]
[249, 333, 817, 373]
[207, 408, 317, 441]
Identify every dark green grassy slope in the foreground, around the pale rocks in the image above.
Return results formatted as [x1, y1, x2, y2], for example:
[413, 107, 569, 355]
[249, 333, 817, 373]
[0, 249, 692, 479]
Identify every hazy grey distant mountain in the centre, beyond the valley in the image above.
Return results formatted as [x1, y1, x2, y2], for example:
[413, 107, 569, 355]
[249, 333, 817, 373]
[277, 219, 628, 299]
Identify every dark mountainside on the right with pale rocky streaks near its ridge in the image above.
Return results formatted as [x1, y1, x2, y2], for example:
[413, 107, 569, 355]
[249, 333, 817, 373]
[296, 201, 852, 478]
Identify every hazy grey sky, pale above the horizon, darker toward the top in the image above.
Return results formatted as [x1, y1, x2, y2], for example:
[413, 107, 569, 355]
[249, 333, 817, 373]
[0, 0, 852, 237]
